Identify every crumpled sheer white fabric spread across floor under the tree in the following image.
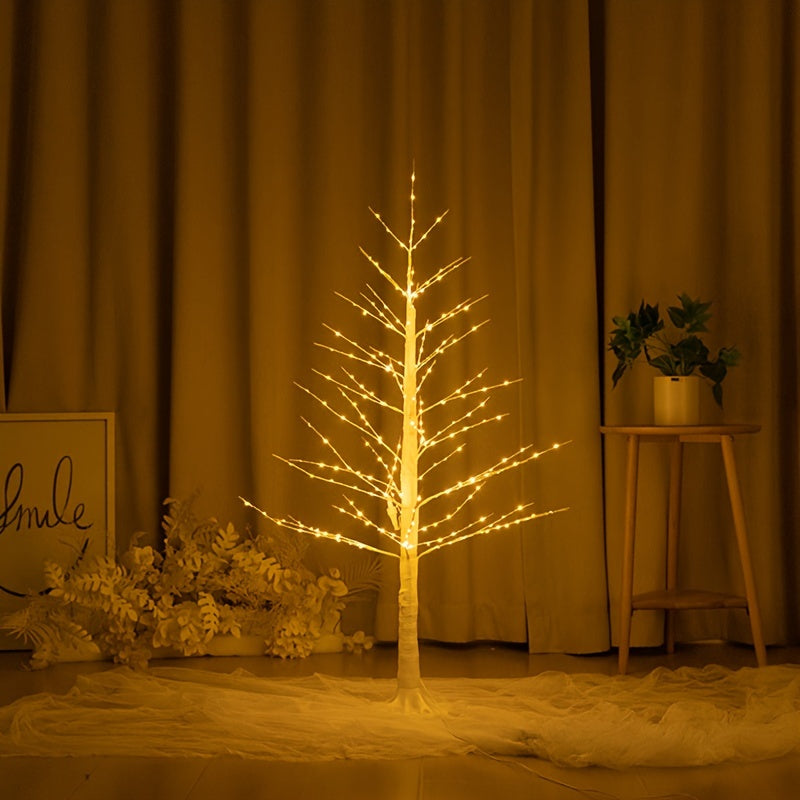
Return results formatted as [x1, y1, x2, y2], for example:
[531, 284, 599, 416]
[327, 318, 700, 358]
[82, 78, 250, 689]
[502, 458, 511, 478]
[0, 666, 800, 767]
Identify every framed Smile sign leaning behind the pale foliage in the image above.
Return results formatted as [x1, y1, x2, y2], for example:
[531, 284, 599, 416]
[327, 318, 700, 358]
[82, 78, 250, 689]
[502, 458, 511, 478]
[0, 413, 114, 650]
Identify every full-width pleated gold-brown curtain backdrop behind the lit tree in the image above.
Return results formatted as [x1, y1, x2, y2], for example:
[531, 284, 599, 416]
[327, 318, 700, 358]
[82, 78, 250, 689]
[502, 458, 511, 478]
[0, 0, 800, 652]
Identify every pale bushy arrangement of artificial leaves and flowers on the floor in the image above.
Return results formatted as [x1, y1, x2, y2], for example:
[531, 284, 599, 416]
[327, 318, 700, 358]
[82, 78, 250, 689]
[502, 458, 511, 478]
[0, 498, 376, 669]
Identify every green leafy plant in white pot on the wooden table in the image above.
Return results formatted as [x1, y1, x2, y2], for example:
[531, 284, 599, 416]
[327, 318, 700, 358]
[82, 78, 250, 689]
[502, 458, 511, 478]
[608, 294, 741, 425]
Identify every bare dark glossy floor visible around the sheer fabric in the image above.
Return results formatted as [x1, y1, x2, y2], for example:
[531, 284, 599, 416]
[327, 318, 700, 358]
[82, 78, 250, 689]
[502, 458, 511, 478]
[0, 643, 800, 800]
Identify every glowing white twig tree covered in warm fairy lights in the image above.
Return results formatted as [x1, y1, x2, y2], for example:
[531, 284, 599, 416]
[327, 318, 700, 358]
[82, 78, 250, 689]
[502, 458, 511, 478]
[242, 174, 561, 712]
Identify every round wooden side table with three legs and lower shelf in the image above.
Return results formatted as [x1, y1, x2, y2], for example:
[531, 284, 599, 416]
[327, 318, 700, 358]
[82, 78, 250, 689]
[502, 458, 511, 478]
[600, 425, 767, 674]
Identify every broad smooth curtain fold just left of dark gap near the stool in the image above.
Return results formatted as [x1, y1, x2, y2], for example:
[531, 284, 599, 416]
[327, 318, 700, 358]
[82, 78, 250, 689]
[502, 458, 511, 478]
[511, 3, 609, 653]
